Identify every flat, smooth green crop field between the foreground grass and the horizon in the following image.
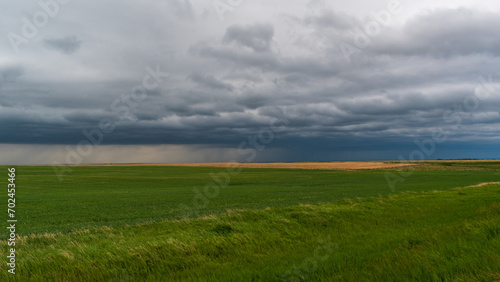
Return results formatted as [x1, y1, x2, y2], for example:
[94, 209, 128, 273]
[0, 164, 500, 235]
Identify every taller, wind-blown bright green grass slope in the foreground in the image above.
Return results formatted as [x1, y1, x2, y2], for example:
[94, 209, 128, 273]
[0, 185, 500, 281]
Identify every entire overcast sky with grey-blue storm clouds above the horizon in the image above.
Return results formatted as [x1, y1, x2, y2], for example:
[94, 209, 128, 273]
[0, 0, 500, 164]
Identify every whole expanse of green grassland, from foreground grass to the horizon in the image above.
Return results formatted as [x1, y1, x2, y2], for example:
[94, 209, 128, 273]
[0, 162, 500, 281]
